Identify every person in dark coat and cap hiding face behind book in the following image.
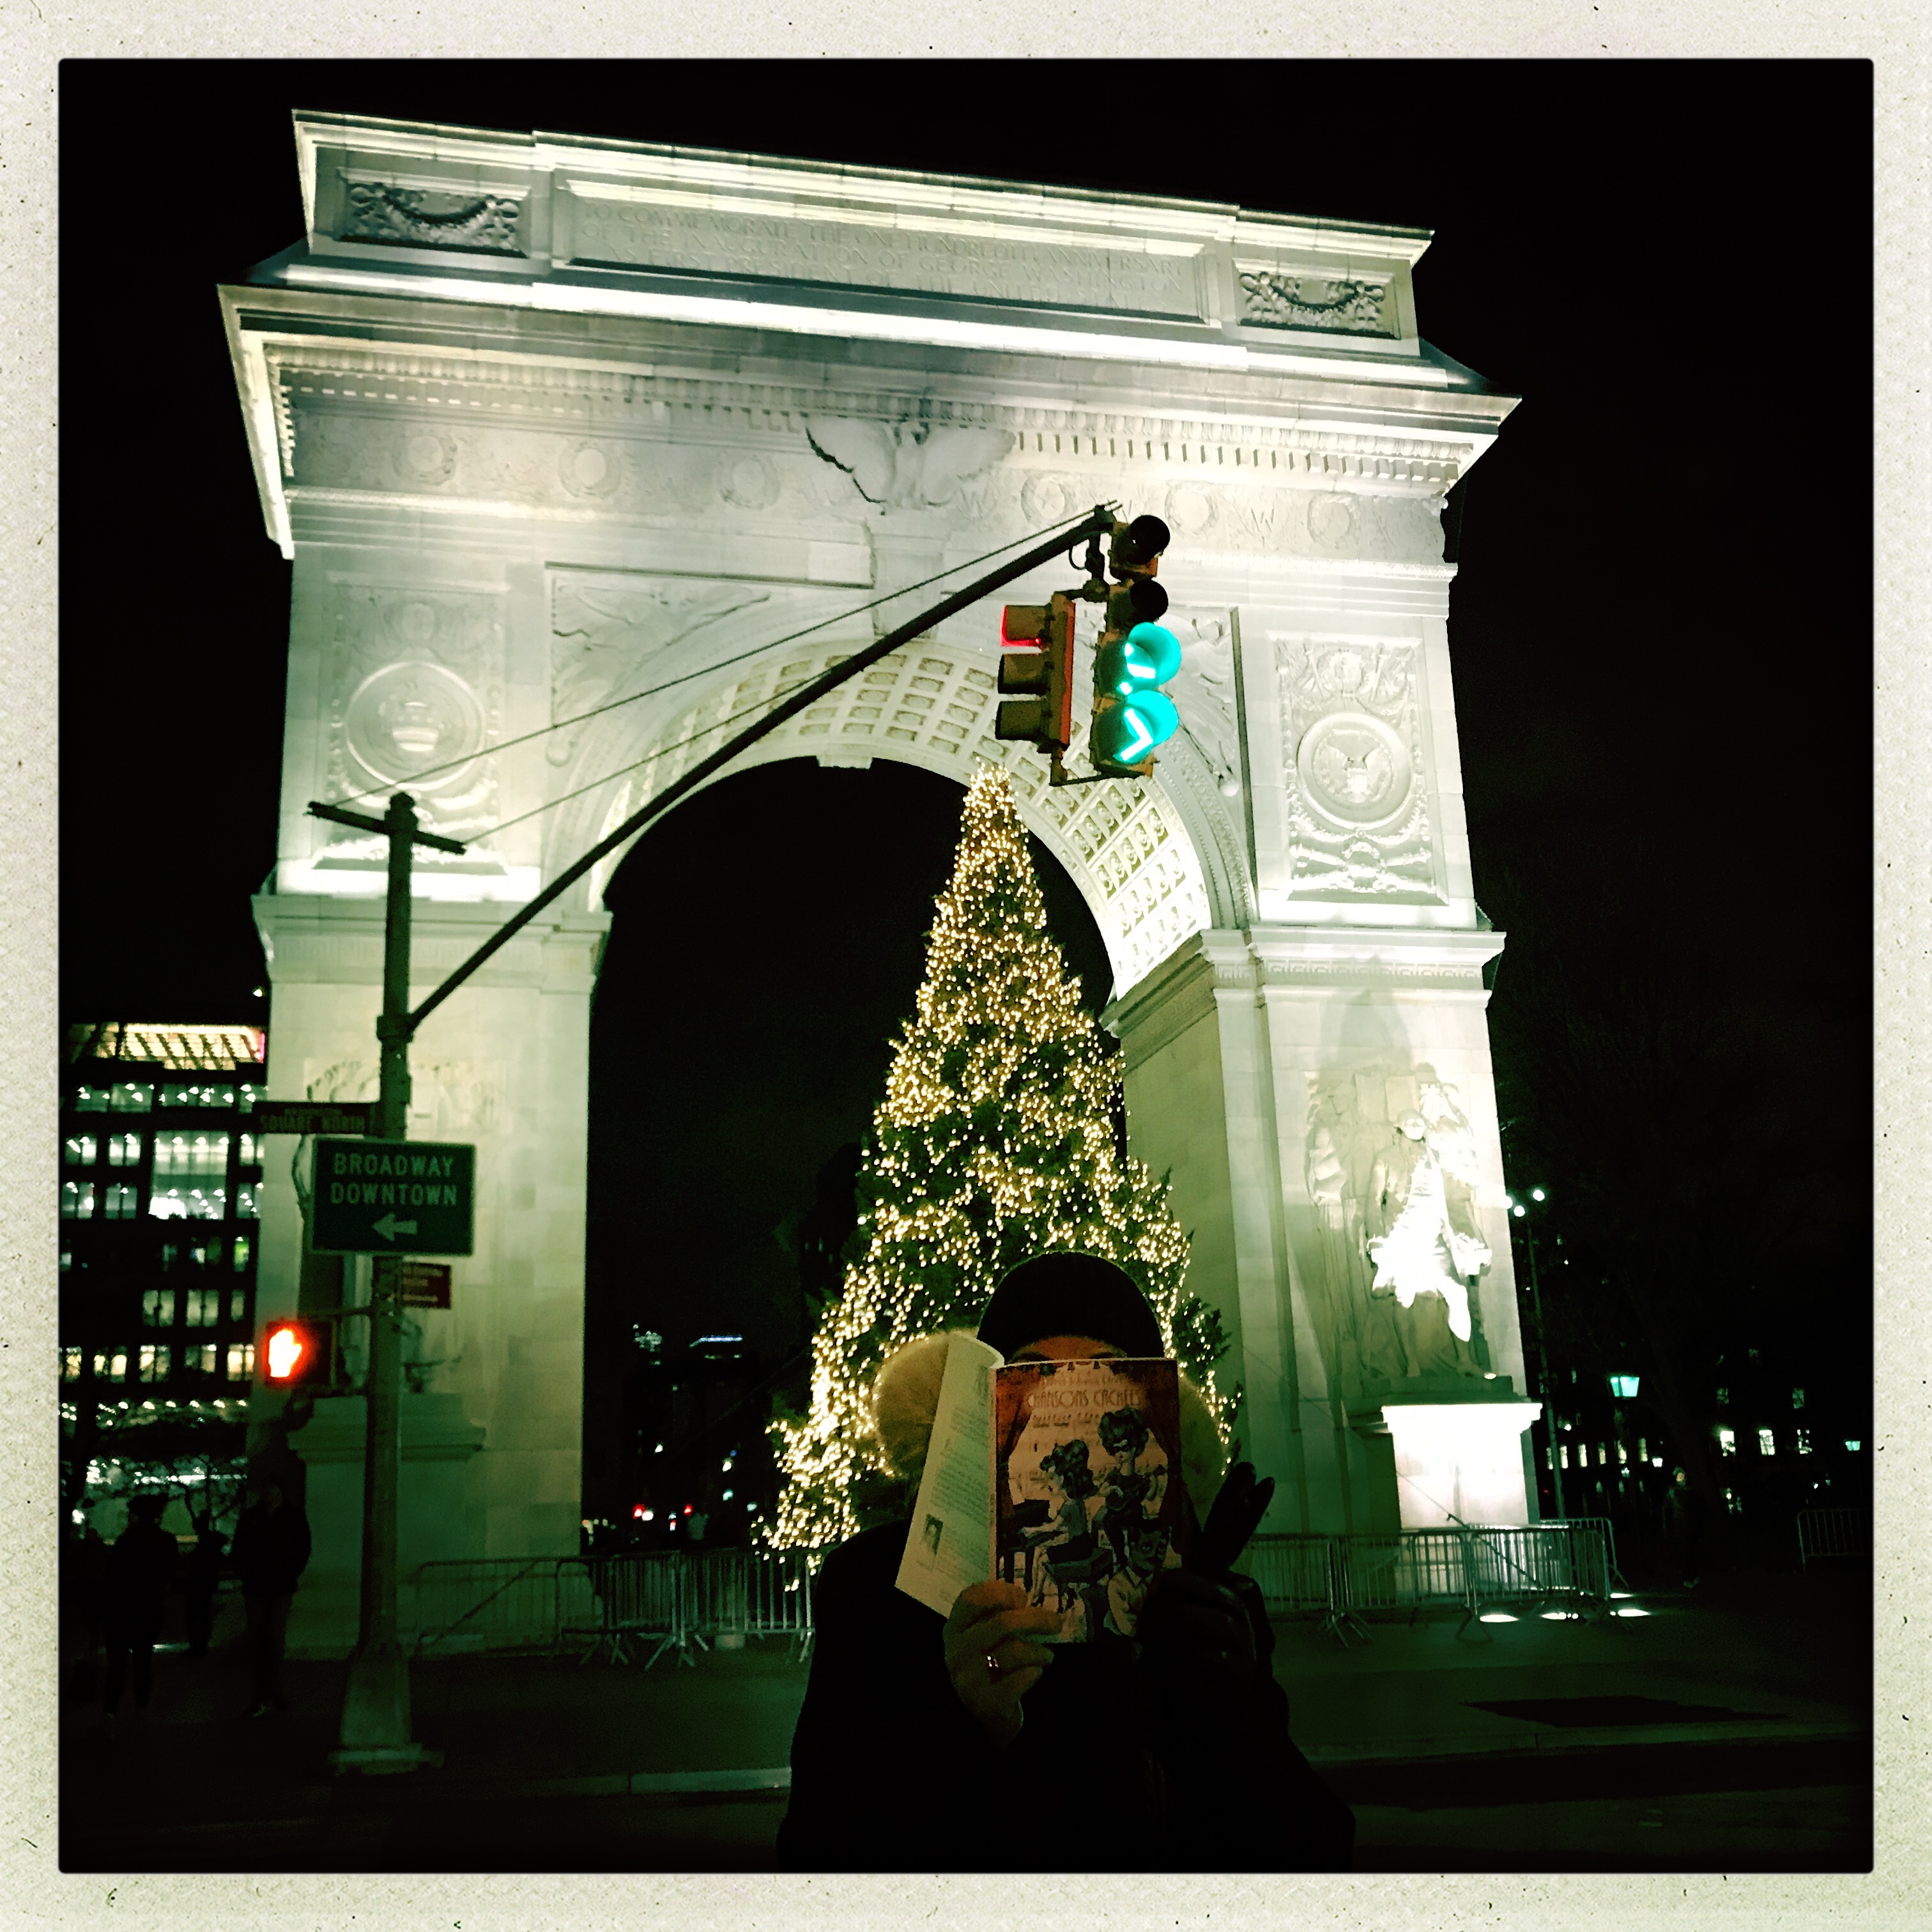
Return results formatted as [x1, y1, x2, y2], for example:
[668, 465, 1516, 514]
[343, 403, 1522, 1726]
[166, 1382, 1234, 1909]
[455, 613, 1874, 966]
[779, 1254, 1354, 1872]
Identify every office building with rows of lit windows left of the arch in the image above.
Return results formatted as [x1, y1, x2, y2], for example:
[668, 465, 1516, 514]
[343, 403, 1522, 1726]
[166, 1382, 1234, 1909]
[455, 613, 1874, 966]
[60, 1022, 266, 1507]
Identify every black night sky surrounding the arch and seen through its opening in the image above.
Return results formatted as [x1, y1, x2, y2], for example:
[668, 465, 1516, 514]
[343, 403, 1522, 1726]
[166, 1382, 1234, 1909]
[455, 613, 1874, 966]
[60, 62, 1872, 1522]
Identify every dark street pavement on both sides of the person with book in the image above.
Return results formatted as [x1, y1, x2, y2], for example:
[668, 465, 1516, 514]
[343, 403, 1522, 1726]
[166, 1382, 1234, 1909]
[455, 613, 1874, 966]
[60, 1575, 1872, 1872]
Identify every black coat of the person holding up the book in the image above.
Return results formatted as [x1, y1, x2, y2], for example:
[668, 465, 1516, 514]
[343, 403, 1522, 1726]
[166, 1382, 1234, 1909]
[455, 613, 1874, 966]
[779, 1522, 1354, 1872]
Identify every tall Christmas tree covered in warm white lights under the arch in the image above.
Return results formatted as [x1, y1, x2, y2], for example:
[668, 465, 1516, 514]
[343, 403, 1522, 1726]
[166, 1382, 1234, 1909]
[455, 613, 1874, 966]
[773, 767, 1232, 1547]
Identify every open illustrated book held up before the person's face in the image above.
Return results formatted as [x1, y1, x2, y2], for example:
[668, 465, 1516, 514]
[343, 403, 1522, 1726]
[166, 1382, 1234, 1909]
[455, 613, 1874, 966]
[898, 1335, 1192, 1642]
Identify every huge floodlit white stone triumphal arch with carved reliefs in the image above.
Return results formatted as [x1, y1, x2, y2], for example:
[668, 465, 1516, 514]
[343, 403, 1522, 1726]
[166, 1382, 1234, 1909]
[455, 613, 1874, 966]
[222, 116, 1536, 1652]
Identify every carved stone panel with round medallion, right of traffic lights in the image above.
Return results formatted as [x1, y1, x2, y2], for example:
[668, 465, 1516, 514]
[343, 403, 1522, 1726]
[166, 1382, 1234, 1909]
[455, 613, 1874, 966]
[1269, 632, 1443, 900]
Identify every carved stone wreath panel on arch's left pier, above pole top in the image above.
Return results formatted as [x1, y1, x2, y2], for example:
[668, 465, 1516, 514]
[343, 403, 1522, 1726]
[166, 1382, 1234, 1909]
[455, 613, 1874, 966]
[319, 578, 504, 868]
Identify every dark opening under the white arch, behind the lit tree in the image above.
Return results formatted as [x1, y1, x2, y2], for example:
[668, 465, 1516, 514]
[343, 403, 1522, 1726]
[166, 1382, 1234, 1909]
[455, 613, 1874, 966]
[583, 759, 1113, 1544]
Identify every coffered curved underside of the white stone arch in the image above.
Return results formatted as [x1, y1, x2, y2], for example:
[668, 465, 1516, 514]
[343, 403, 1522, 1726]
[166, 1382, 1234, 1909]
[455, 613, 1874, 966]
[556, 640, 1225, 995]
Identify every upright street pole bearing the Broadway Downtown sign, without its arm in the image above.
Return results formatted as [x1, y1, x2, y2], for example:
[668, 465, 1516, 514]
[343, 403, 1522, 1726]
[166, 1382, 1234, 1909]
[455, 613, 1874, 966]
[309, 792, 464, 1772]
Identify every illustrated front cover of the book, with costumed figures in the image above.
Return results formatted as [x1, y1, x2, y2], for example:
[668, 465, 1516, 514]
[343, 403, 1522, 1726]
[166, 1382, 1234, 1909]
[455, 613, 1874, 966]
[993, 1360, 1186, 1642]
